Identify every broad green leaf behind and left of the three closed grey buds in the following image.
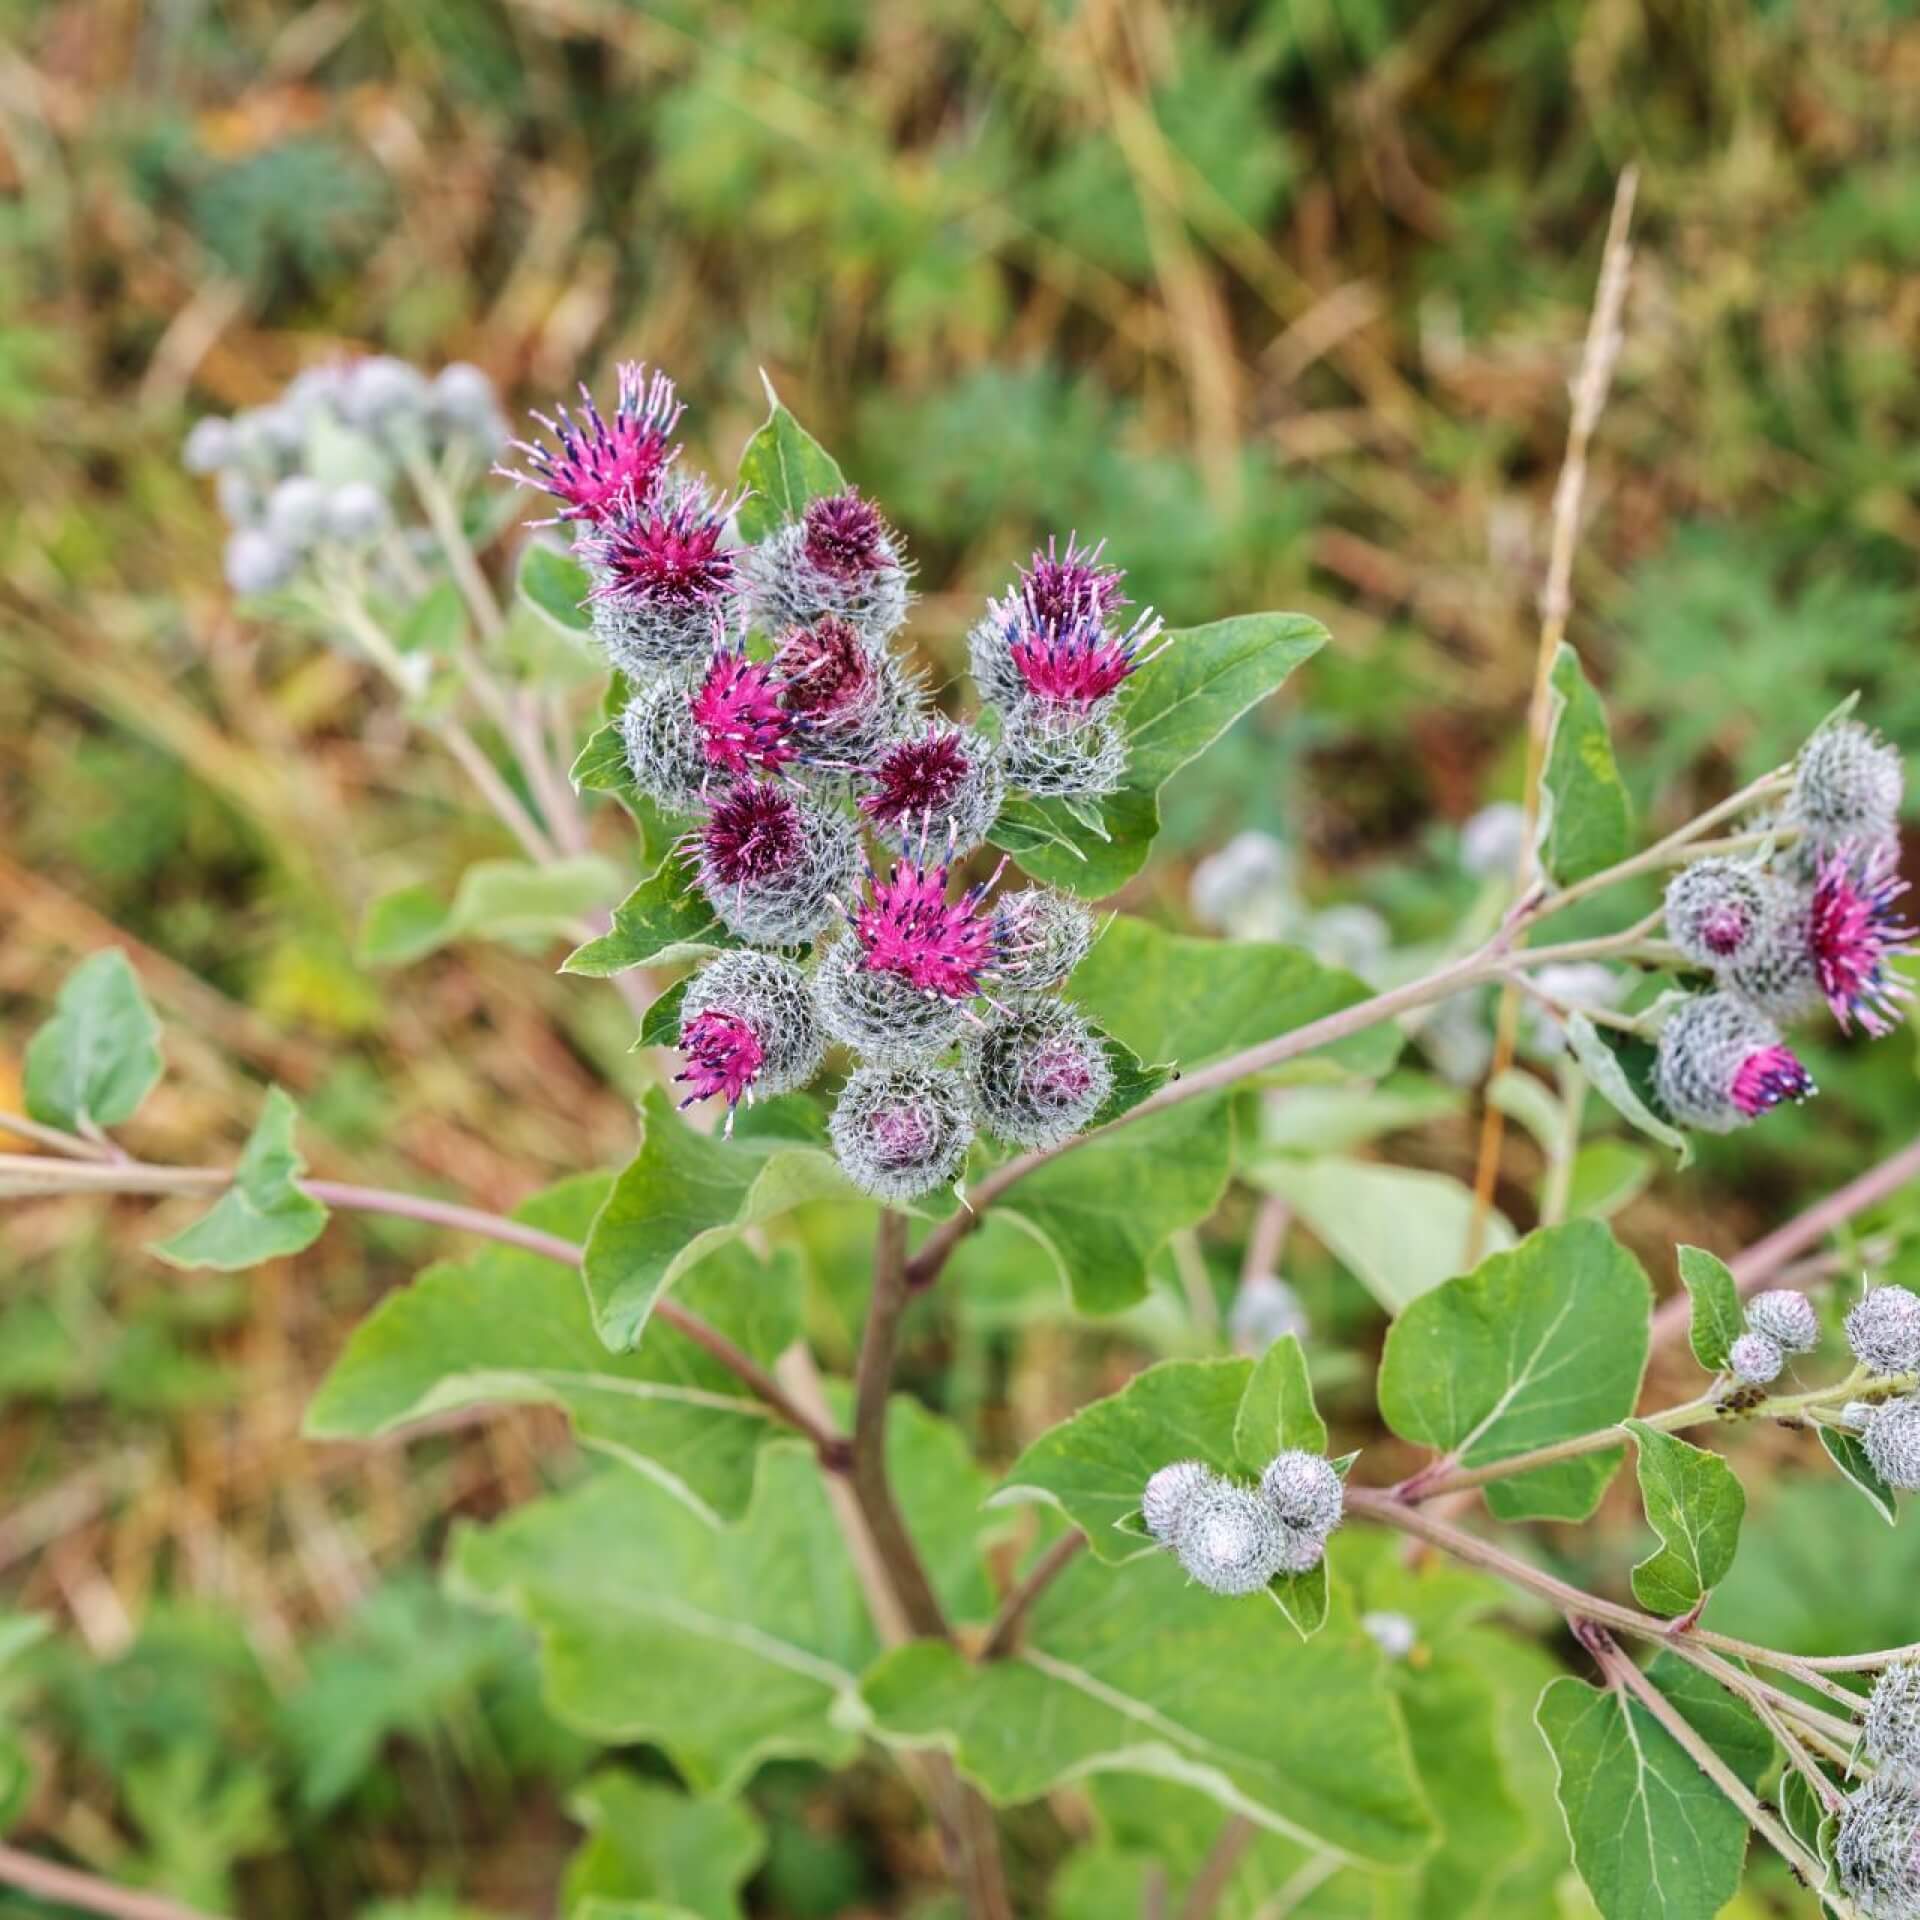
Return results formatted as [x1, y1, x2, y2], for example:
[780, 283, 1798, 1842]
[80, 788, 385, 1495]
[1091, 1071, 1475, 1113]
[993, 1359, 1271, 1565]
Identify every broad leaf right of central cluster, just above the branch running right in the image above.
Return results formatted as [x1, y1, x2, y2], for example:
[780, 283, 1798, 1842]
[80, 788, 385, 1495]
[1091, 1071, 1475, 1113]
[1071, 914, 1400, 1079]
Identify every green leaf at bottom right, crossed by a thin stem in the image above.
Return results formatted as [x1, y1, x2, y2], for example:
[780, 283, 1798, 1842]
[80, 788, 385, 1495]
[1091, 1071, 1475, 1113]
[1536, 1657, 1764, 1920]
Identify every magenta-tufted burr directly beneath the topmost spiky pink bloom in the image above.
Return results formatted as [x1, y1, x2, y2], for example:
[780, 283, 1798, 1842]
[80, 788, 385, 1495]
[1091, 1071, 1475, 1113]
[574, 474, 743, 680]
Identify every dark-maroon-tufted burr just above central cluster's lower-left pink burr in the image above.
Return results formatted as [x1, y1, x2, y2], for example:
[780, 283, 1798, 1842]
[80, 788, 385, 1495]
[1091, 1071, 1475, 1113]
[697, 780, 860, 947]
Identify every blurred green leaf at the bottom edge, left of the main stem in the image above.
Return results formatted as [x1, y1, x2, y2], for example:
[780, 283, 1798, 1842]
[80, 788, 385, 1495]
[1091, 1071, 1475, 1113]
[561, 1770, 766, 1920]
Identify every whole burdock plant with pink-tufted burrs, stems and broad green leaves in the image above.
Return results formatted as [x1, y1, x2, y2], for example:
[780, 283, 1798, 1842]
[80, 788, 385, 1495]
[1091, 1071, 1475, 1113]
[22, 266, 1920, 1920]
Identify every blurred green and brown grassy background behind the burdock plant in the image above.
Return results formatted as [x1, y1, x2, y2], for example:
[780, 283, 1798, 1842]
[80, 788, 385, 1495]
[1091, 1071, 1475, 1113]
[0, 0, 1920, 1920]
